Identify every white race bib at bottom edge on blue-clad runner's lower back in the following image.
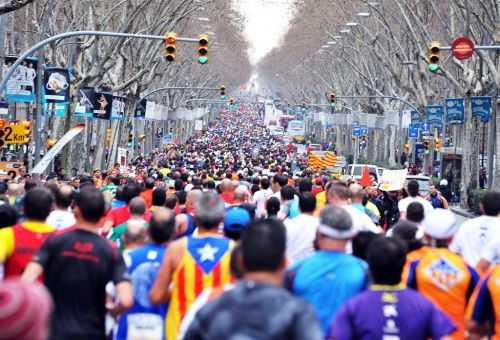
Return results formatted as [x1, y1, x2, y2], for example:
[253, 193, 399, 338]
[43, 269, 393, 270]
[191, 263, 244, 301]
[127, 313, 164, 340]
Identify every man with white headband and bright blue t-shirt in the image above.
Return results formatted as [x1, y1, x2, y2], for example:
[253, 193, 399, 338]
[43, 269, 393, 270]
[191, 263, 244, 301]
[285, 205, 367, 334]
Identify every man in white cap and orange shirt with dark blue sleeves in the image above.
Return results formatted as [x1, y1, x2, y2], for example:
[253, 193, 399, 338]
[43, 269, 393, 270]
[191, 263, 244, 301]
[408, 209, 479, 339]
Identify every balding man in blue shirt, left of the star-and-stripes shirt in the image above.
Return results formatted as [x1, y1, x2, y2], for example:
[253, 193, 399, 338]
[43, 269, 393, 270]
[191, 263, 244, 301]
[113, 208, 175, 340]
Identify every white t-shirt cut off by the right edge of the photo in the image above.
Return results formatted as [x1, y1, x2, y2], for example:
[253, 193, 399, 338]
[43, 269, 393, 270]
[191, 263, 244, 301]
[450, 215, 500, 267]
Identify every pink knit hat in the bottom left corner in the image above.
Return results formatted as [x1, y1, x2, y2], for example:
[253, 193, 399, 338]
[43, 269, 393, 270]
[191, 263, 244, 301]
[0, 279, 53, 340]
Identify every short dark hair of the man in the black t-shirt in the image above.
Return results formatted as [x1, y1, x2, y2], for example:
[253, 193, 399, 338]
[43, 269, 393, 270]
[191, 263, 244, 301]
[75, 186, 106, 223]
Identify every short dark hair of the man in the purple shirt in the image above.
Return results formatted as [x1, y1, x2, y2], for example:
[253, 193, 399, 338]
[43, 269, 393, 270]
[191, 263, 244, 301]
[367, 237, 406, 285]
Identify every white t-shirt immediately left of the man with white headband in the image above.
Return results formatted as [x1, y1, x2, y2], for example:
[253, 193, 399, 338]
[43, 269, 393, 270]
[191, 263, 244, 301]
[284, 214, 319, 262]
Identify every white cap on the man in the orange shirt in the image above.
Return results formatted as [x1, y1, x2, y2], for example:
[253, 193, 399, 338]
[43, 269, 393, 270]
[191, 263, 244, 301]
[422, 209, 458, 240]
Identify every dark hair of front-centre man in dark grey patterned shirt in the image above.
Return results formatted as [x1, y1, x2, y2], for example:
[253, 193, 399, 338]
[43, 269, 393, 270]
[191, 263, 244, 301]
[241, 219, 286, 272]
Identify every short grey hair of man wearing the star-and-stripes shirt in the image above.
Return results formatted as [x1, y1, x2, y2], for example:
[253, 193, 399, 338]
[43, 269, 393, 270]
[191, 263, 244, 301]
[194, 192, 225, 229]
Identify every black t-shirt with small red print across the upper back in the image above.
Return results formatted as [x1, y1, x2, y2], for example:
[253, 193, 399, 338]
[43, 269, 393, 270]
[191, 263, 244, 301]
[34, 229, 129, 340]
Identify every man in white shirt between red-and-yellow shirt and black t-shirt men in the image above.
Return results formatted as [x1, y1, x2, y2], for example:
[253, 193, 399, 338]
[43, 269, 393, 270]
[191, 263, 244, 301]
[46, 184, 76, 230]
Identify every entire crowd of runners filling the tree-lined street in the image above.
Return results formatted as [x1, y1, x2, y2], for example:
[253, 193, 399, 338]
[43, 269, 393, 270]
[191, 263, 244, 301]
[0, 105, 500, 340]
